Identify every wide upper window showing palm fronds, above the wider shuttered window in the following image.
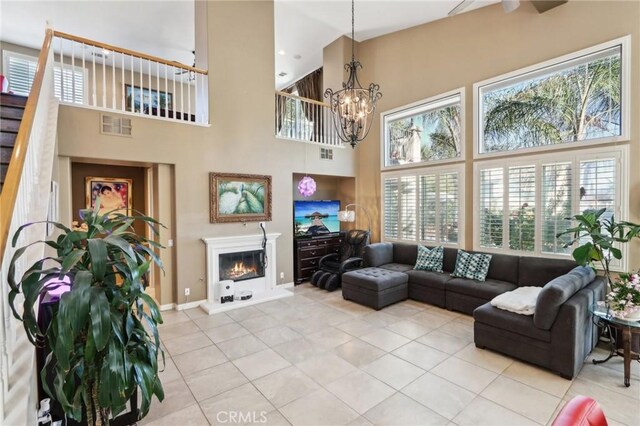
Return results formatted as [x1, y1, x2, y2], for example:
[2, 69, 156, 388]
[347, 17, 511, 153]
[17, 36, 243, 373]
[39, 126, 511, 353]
[474, 38, 628, 155]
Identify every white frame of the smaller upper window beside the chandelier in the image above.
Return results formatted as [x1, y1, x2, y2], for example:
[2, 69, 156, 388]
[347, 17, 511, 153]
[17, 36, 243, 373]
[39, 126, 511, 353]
[380, 87, 466, 170]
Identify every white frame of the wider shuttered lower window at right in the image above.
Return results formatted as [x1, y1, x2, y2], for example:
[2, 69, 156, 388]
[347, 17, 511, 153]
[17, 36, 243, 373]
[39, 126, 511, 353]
[473, 144, 630, 271]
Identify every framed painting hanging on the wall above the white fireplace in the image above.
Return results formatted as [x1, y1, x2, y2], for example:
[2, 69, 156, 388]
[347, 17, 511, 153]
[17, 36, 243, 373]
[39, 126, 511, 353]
[209, 173, 271, 223]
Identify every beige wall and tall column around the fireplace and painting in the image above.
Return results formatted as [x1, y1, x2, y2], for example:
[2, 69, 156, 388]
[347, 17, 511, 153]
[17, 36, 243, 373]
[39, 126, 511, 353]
[58, 1, 355, 304]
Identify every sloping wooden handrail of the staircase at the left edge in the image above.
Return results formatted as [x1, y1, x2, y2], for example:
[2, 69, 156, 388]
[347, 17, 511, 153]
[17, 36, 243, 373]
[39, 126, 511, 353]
[0, 29, 53, 260]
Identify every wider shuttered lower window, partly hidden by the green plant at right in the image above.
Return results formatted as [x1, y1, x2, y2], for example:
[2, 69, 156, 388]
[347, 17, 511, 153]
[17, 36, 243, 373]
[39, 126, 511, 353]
[475, 147, 628, 262]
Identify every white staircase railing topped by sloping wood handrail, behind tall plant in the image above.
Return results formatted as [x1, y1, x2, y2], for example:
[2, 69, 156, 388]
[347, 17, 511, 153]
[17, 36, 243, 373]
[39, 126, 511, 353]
[0, 30, 58, 425]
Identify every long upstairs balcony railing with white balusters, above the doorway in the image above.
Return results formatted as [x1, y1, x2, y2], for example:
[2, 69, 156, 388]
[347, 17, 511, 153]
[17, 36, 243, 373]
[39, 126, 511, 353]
[54, 31, 209, 124]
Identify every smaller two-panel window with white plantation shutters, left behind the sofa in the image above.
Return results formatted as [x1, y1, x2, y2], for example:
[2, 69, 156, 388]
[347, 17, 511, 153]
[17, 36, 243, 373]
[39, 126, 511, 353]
[382, 166, 464, 246]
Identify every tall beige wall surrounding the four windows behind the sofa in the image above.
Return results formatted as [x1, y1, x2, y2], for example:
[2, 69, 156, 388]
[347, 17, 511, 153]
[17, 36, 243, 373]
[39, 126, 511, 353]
[356, 1, 640, 262]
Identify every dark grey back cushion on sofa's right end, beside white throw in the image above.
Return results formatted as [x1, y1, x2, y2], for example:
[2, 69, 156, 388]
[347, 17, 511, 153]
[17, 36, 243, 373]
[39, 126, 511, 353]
[533, 266, 596, 330]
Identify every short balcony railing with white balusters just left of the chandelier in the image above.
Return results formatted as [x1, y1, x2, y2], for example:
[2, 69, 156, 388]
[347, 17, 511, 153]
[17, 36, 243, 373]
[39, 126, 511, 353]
[275, 92, 343, 148]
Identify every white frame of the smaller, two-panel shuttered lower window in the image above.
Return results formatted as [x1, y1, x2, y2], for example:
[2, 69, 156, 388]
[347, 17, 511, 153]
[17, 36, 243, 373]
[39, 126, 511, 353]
[380, 163, 466, 248]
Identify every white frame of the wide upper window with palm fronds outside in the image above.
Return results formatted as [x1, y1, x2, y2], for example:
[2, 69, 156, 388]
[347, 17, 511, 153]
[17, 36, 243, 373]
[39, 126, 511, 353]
[473, 35, 631, 159]
